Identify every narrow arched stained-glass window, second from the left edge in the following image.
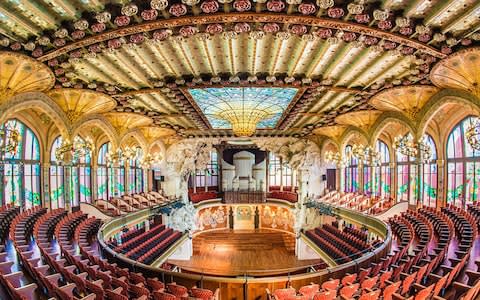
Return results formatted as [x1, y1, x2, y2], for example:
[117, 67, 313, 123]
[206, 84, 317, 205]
[50, 136, 66, 209]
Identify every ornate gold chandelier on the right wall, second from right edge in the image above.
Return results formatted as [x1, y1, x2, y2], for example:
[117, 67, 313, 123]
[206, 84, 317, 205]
[393, 133, 432, 163]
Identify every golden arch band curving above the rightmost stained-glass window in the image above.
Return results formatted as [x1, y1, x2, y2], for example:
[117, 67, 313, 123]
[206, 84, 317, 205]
[417, 89, 480, 137]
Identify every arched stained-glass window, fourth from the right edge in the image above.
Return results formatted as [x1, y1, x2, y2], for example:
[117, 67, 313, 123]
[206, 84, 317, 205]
[375, 140, 392, 198]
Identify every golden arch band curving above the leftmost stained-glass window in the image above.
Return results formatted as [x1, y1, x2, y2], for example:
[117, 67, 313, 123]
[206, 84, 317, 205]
[0, 92, 72, 138]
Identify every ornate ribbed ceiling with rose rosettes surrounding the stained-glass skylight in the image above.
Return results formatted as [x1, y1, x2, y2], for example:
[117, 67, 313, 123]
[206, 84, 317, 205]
[0, 0, 480, 136]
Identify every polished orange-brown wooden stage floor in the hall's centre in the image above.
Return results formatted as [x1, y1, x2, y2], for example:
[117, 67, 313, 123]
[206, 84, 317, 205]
[168, 229, 322, 276]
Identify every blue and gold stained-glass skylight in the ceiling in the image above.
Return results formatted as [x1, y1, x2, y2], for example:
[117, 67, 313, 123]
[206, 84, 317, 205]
[189, 87, 298, 135]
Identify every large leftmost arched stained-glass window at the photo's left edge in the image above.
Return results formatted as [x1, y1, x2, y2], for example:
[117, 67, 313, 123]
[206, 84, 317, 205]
[0, 119, 41, 209]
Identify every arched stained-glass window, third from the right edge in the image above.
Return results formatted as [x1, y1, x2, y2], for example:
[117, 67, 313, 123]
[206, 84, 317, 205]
[396, 150, 418, 205]
